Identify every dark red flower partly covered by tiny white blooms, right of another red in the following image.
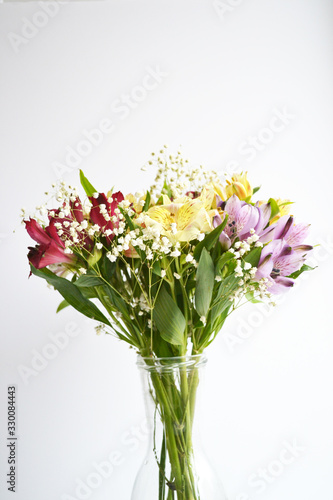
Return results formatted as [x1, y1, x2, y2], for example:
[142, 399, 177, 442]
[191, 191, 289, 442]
[89, 191, 124, 243]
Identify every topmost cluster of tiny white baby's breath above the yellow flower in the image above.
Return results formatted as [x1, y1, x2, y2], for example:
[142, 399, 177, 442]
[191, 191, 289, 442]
[141, 145, 220, 200]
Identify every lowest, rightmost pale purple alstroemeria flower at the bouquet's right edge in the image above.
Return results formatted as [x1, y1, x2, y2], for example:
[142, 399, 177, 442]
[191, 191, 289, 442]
[255, 239, 312, 294]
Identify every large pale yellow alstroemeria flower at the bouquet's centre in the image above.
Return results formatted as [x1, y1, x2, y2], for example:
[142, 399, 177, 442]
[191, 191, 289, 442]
[144, 191, 216, 242]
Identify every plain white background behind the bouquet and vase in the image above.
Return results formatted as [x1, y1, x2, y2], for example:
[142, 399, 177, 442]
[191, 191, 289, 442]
[0, 0, 333, 500]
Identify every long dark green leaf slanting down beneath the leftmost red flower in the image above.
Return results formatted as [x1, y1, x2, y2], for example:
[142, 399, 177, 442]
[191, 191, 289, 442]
[30, 264, 111, 326]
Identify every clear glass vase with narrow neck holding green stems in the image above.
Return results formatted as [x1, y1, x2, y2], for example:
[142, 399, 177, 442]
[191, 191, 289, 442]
[131, 355, 227, 500]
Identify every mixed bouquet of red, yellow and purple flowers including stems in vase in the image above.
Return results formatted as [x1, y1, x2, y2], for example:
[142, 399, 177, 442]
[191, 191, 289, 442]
[23, 150, 312, 499]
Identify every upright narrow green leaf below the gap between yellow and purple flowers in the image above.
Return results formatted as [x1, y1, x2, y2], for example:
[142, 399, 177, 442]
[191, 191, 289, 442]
[195, 248, 215, 317]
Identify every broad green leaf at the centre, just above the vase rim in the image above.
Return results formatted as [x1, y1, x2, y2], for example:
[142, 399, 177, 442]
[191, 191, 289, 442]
[153, 287, 186, 346]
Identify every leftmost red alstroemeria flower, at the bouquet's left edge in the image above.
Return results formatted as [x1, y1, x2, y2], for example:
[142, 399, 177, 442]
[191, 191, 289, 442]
[25, 219, 75, 269]
